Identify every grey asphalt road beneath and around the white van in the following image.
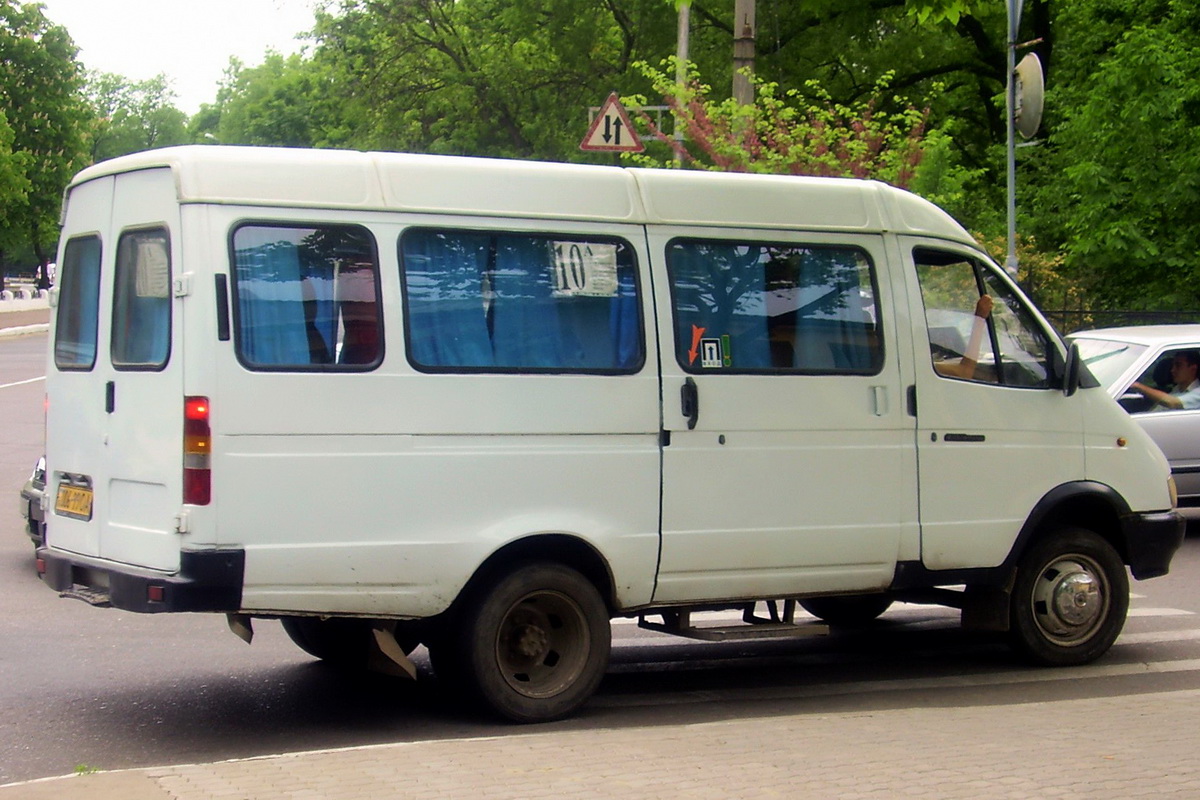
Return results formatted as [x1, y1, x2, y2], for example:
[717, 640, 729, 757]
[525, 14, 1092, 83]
[0, 335, 1200, 783]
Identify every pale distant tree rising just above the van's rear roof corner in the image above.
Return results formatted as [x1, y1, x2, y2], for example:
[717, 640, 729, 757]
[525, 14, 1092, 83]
[86, 72, 188, 162]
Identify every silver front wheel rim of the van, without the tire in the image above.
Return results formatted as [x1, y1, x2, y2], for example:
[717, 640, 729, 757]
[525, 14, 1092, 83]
[1031, 553, 1112, 646]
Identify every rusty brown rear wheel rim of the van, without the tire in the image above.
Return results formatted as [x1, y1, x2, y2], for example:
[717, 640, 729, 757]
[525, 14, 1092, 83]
[496, 590, 592, 698]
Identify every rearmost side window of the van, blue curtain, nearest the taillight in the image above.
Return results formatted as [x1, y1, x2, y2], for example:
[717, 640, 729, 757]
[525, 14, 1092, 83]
[233, 223, 383, 371]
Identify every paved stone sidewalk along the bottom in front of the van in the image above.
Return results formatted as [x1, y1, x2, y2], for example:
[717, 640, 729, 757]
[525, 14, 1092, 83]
[0, 690, 1200, 800]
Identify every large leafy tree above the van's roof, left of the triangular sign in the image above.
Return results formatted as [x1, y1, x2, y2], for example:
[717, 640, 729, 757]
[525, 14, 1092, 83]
[313, 0, 674, 160]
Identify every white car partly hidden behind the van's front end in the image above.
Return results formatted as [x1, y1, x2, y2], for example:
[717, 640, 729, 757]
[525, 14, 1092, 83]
[1067, 325, 1200, 506]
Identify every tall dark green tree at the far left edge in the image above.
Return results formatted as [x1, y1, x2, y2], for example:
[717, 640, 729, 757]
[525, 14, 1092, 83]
[0, 0, 89, 284]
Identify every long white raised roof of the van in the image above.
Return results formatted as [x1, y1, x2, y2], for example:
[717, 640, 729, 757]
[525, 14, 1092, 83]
[64, 145, 973, 243]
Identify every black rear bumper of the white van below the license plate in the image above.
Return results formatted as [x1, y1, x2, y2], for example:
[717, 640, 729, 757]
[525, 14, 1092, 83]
[37, 547, 246, 614]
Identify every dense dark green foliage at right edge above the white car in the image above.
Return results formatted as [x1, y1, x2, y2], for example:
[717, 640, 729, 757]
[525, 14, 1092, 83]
[1036, 0, 1200, 309]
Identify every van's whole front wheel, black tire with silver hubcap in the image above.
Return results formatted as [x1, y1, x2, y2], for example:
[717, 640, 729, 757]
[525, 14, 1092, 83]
[1009, 528, 1129, 667]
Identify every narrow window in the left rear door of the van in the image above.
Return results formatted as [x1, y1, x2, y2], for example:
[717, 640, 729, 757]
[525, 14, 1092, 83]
[54, 231, 101, 371]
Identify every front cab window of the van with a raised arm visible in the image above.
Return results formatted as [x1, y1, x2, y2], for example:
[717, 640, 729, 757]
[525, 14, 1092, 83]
[913, 248, 1050, 389]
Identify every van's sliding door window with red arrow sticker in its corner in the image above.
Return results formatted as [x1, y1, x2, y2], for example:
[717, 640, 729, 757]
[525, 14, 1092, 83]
[667, 240, 883, 375]
